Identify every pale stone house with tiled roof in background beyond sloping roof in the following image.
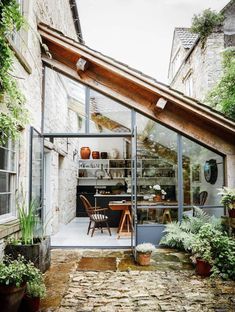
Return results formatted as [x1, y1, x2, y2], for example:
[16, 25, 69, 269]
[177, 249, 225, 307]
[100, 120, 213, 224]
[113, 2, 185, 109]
[168, 0, 235, 101]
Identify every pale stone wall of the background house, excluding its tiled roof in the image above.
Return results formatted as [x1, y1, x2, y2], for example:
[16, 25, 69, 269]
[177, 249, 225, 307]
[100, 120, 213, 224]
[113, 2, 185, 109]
[170, 32, 224, 101]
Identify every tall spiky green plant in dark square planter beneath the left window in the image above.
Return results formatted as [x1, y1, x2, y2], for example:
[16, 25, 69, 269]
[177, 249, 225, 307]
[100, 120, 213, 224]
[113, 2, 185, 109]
[5, 200, 51, 272]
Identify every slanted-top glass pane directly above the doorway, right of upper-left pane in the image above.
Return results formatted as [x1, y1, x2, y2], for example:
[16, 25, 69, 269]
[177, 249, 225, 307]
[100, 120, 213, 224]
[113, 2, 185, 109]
[89, 90, 132, 133]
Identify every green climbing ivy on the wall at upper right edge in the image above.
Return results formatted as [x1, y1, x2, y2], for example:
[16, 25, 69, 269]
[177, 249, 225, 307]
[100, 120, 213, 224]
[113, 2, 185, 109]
[206, 47, 235, 120]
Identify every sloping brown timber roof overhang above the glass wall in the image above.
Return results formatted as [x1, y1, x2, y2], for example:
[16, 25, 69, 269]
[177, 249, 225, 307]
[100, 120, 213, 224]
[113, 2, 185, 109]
[39, 24, 235, 154]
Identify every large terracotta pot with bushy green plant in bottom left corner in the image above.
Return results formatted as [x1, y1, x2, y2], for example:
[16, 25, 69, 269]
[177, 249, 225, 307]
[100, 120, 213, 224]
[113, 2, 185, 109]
[0, 256, 40, 312]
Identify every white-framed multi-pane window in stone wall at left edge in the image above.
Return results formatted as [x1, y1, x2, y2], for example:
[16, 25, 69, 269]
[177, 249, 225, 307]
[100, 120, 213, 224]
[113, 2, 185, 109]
[0, 142, 16, 221]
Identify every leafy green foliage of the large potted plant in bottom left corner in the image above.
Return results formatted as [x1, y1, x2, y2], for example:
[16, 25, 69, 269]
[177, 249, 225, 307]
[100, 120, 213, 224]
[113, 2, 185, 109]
[0, 255, 42, 287]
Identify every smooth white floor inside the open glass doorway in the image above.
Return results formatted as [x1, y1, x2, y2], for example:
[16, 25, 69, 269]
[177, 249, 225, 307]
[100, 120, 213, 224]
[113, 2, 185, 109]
[51, 218, 131, 247]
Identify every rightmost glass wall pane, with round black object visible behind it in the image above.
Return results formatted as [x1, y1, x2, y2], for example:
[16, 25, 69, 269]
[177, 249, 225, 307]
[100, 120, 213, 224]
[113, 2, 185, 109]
[182, 137, 224, 215]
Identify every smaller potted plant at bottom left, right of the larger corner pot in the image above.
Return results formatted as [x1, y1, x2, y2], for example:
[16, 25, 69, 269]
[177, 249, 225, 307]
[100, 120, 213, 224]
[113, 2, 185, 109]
[20, 275, 46, 312]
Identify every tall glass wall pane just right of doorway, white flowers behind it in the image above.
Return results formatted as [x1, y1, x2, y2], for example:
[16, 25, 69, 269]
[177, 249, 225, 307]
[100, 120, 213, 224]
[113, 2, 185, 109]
[137, 114, 178, 224]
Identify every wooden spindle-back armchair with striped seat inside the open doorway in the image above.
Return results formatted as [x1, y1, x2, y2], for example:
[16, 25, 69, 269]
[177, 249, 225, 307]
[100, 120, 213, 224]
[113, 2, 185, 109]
[80, 195, 111, 237]
